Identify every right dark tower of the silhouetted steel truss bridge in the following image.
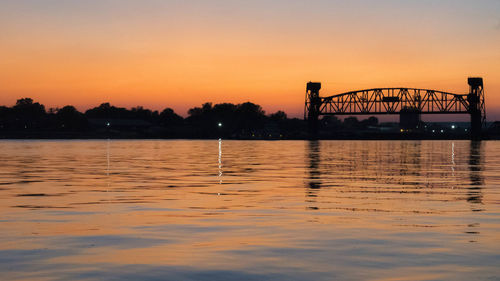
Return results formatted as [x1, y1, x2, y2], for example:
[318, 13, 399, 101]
[467, 77, 486, 140]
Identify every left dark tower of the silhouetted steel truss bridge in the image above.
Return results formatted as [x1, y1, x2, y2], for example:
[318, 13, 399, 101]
[304, 82, 321, 139]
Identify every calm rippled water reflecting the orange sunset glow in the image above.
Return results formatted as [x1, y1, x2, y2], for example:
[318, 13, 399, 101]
[0, 140, 500, 280]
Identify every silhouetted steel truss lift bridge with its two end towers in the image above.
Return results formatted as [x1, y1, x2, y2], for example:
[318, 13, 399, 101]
[304, 77, 486, 139]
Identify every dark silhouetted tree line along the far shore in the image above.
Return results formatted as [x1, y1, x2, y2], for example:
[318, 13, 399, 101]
[0, 98, 378, 139]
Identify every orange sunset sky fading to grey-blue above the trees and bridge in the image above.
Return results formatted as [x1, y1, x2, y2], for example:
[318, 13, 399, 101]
[0, 0, 500, 120]
